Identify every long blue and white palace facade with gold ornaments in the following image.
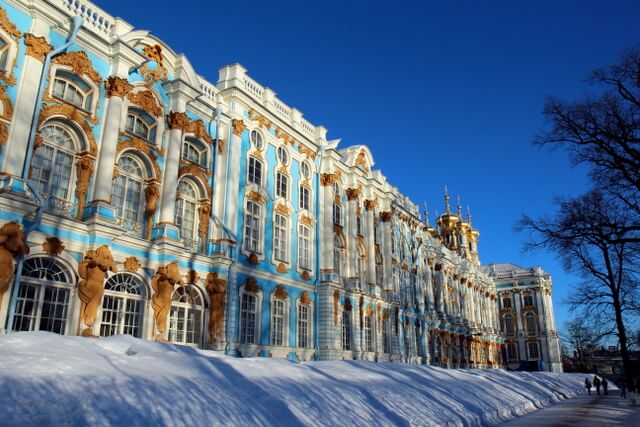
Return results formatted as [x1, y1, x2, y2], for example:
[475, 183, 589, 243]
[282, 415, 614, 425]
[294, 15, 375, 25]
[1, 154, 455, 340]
[0, 0, 561, 371]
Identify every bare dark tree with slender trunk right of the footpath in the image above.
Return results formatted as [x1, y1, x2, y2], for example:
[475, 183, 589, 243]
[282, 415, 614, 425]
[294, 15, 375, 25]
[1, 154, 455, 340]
[519, 190, 640, 379]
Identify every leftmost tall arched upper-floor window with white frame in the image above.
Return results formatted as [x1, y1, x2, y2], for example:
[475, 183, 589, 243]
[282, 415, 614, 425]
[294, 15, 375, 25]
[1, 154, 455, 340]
[30, 123, 76, 216]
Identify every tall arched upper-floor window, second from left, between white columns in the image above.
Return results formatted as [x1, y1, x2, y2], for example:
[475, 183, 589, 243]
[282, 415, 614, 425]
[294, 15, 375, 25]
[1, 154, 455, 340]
[112, 154, 145, 234]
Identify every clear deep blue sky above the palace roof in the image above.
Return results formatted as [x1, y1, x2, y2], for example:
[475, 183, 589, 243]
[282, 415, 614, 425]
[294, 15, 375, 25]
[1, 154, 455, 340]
[94, 0, 640, 332]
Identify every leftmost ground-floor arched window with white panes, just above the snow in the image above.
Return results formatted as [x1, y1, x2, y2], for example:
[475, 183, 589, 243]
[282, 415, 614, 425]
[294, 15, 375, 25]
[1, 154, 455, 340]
[11, 257, 74, 334]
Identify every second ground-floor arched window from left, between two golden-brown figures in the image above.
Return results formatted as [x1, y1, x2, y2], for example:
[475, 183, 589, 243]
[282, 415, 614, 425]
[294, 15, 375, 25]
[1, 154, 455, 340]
[100, 273, 147, 338]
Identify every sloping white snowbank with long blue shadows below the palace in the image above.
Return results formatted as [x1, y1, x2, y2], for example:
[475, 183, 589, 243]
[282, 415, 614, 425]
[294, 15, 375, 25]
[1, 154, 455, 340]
[0, 332, 584, 426]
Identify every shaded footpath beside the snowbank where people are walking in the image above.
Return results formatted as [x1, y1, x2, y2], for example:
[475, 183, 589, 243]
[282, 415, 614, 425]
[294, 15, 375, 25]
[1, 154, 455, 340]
[500, 390, 640, 427]
